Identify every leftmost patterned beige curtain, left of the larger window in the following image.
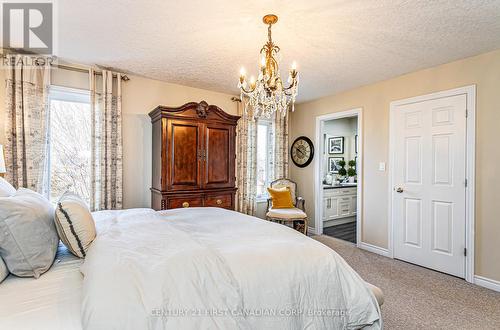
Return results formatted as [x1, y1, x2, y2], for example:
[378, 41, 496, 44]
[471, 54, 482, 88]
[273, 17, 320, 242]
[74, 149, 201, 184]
[5, 55, 50, 197]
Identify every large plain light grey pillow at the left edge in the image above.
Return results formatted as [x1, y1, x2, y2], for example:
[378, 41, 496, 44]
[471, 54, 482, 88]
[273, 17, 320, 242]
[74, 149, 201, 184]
[0, 188, 59, 278]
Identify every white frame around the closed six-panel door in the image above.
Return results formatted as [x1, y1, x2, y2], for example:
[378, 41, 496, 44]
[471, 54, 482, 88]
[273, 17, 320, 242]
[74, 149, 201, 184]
[388, 85, 476, 283]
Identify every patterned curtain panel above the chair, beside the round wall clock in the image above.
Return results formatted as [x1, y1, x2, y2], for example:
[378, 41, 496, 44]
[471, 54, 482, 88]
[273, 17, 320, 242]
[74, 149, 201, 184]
[271, 111, 289, 180]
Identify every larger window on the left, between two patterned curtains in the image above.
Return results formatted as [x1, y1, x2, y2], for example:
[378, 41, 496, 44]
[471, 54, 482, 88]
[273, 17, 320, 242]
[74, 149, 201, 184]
[48, 86, 92, 203]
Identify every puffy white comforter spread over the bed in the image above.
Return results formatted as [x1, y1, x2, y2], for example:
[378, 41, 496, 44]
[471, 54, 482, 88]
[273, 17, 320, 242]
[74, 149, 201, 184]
[81, 208, 381, 330]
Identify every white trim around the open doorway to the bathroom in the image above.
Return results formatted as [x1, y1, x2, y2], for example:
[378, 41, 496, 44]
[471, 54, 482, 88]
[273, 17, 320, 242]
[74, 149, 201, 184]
[314, 108, 363, 246]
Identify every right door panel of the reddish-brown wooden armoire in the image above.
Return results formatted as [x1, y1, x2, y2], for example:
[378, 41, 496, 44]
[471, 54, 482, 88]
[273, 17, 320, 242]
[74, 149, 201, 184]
[204, 125, 234, 188]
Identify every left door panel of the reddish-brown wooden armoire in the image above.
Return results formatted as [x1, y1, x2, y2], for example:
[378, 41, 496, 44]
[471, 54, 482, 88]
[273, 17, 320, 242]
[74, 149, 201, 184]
[168, 120, 203, 189]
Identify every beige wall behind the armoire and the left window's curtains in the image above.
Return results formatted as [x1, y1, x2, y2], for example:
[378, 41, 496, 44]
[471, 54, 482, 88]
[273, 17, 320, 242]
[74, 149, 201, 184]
[0, 70, 237, 208]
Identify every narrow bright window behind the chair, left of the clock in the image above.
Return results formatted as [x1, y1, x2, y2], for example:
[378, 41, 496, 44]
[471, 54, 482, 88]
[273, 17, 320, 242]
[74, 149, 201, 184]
[257, 120, 273, 200]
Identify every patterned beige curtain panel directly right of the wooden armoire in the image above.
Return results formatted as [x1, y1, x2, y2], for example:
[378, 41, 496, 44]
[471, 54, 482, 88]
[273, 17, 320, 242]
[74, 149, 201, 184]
[236, 102, 257, 215]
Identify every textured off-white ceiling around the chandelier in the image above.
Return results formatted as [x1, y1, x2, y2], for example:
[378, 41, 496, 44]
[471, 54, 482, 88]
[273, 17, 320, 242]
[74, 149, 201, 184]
[58, 0, 500, 101]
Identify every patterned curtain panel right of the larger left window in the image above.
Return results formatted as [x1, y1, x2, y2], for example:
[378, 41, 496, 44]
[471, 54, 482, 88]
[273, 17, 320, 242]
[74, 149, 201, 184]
[89, 69, 123, 210]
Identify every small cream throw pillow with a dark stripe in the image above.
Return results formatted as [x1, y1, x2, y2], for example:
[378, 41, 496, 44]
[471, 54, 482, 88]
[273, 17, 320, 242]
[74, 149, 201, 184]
[55, 192, 96, 258]
